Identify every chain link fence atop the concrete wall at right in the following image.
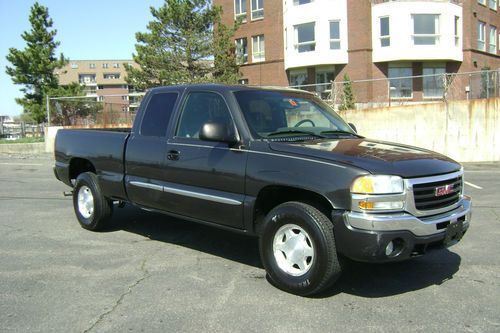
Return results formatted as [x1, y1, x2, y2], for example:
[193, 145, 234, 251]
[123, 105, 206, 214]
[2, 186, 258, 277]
[291, 70, 500, 110]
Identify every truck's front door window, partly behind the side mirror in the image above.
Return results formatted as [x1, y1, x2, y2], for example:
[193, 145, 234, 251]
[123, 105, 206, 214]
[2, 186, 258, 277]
[176, 92, 232, 139]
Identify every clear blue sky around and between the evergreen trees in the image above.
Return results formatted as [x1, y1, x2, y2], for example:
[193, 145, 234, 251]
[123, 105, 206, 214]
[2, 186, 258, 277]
[0, 0, 164, 116]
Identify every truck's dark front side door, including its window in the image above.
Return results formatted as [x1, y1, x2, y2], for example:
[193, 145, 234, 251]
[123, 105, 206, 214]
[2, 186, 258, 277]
[163, 90, 247, 229]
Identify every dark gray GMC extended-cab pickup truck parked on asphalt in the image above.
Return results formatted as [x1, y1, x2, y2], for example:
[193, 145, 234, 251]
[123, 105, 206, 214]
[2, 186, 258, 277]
[54, 85, 471, 295]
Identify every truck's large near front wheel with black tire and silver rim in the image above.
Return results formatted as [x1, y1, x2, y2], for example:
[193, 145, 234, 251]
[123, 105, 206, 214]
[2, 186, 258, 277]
[259, 202, 341, 296]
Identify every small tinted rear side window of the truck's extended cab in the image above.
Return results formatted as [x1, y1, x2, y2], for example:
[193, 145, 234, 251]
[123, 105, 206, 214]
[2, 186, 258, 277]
[140, 93, 178, 137]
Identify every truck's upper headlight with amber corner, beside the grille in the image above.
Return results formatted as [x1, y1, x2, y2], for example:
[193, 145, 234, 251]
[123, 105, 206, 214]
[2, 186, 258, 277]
[351, 175, 404, 194]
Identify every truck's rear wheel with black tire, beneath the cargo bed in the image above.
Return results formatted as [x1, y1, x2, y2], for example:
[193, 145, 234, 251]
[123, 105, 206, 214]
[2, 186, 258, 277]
[73, 172, 113, 231]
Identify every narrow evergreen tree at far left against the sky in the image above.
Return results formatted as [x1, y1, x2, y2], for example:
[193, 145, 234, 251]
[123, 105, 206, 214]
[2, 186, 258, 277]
[6, 2, 66, 123]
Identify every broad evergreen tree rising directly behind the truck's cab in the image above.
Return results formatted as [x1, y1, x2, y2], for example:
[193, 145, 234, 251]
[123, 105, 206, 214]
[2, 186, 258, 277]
[126, 0, 239, 90]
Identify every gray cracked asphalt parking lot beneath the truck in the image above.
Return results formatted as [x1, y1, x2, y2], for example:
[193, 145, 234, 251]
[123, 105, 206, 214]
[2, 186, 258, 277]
[0, 155, 500, 333]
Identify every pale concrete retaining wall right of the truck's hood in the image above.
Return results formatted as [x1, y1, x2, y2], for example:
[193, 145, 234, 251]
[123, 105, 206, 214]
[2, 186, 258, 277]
[339, 98, 500, 162]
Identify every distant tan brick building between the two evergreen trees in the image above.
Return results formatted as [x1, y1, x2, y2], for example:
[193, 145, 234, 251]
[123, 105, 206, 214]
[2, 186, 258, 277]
[56, 60, 138, 111]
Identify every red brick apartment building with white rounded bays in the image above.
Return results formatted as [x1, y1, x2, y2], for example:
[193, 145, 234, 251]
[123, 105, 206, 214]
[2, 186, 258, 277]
[213, 0, 500, 102]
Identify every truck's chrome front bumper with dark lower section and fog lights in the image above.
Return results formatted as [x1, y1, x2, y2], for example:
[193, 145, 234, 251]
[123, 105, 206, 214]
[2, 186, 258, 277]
[333, 196, 472, 262]
